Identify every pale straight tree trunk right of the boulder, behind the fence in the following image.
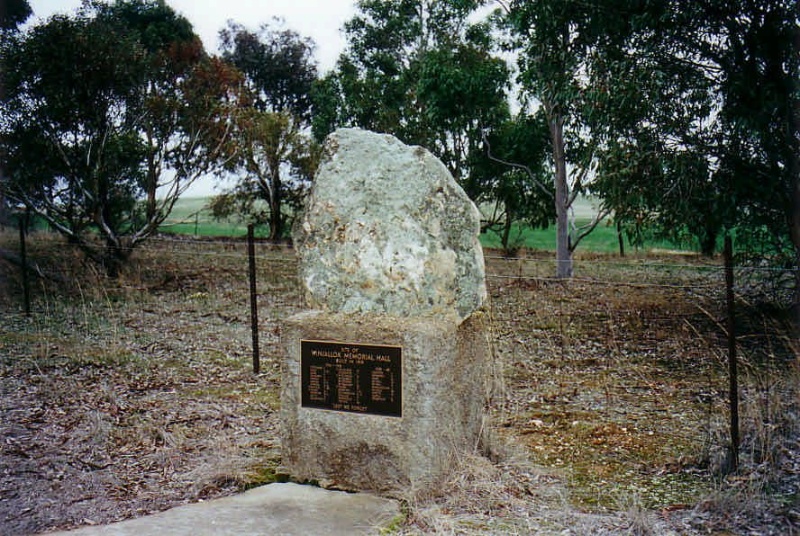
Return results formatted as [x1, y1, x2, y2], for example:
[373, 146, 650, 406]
[548, 109, 572, 279]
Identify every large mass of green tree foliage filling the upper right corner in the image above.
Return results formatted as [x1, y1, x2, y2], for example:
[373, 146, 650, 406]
[500, 0, 800, 289]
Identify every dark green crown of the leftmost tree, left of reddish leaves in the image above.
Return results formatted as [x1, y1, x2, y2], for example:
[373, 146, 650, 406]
[4, 10, 152, 245]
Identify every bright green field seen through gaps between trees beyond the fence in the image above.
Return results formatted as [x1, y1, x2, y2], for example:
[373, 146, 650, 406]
[161, 197, 682, 253]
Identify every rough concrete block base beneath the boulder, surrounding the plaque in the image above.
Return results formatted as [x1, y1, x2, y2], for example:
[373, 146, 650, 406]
[281, 311, 489, 495]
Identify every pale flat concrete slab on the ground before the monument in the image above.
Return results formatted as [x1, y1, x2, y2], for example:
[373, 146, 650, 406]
[39, 484, 400, 536]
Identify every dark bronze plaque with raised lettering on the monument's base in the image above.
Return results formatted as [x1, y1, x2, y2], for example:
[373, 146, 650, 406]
[300, 341, 403, 417]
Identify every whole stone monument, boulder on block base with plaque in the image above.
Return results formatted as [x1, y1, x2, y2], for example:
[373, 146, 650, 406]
[281, 129, 489, 495]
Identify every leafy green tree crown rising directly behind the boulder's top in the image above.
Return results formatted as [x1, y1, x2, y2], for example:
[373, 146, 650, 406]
[314, 0, 510, 183]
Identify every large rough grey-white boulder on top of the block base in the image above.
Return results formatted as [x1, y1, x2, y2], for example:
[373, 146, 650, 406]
[294, 129, 486, 320]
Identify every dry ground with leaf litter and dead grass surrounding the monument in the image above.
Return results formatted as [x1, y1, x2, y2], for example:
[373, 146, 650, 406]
[0, 233, 800, 536]
